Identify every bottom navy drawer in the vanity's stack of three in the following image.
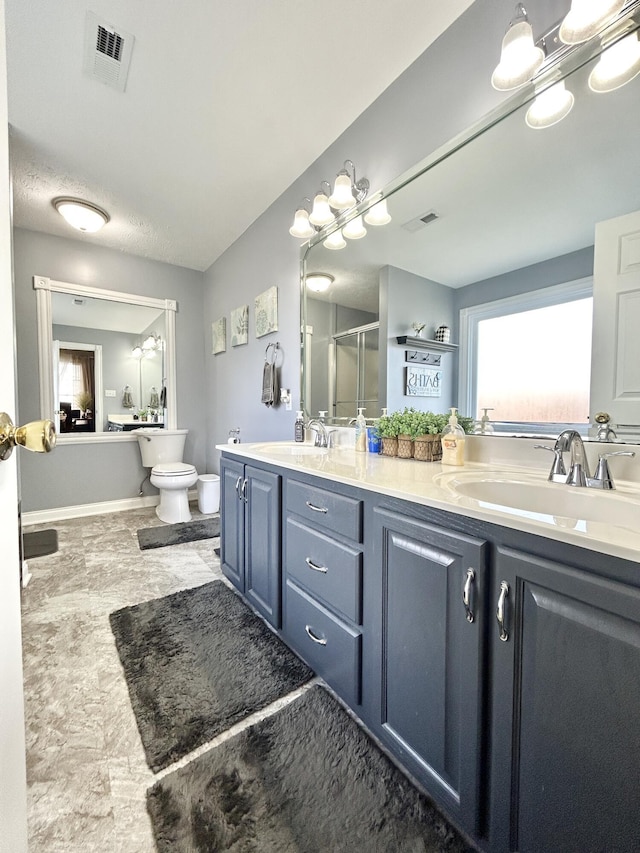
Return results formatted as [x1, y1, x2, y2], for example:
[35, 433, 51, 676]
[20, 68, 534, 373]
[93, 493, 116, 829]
[284, 580, 362, 705]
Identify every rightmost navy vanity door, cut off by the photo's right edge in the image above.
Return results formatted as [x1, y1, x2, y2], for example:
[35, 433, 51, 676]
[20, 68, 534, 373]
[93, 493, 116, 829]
[490, 548, 640, 853]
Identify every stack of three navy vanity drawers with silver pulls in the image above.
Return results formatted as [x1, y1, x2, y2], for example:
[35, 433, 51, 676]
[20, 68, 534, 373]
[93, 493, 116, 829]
[283, 476, 363, 710]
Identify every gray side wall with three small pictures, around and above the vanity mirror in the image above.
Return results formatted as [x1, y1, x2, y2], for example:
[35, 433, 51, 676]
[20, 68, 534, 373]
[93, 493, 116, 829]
[204, 0, 566, 470]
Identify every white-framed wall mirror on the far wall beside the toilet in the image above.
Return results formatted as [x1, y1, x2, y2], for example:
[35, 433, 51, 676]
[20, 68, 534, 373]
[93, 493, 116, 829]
[33, 276, 177, 443]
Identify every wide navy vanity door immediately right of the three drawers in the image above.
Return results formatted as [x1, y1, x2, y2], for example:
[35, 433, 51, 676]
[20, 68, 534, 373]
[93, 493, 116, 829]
[363, 508, 485, 833]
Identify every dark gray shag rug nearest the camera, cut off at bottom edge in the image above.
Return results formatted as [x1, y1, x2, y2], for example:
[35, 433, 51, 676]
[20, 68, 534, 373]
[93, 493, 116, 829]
[147, 686, 472, 853]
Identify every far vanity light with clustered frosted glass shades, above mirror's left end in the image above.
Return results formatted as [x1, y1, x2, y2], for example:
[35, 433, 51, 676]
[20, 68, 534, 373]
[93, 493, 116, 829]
[289, 160, 376, 240]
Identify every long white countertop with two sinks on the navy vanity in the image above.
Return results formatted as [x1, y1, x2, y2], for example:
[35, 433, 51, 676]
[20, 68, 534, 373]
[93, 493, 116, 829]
[216, 441, 640, 563]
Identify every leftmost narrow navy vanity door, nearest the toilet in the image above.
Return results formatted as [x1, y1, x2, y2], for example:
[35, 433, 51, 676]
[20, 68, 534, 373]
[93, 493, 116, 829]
[220, 459, 244, 592]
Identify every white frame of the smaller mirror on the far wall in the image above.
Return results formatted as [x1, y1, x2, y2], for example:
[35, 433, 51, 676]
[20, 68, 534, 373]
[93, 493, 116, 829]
[33, 275, 178, 444]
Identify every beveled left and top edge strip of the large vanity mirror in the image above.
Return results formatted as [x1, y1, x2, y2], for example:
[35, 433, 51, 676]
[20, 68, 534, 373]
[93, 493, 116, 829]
[300, 11, 640, 423]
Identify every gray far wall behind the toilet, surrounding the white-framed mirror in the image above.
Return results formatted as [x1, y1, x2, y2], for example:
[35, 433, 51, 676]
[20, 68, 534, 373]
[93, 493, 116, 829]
[14, 229, 207, 512]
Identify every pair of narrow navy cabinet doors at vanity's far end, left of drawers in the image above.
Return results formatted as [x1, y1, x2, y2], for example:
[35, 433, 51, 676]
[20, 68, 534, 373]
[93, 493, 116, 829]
[220, 457, 281, 628]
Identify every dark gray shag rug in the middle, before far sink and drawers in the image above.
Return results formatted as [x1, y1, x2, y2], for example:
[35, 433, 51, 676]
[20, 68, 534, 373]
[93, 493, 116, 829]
[109, 581, 313, 772]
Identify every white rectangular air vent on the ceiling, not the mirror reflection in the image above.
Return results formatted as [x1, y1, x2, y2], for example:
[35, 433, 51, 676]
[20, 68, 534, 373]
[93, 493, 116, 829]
[84, 12, 134, 92]
